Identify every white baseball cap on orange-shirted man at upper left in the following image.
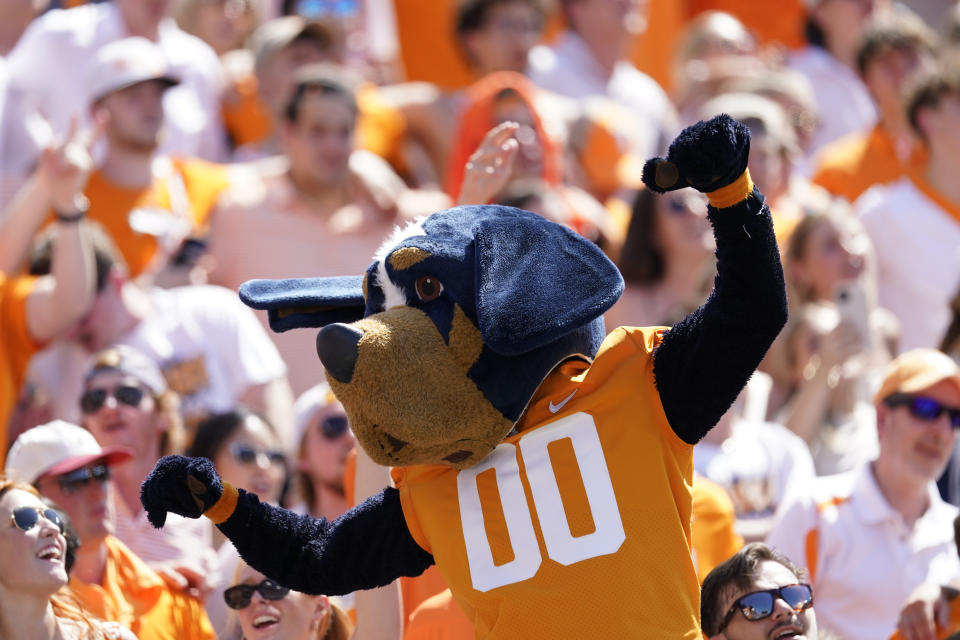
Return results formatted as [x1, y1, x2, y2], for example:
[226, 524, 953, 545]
[87, 37, 180, 104]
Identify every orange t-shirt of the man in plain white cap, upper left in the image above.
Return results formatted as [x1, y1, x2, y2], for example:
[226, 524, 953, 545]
[76, 158, 229, 278]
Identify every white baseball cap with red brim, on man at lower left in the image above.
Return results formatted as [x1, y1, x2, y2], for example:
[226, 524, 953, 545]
[4, 420, 133, 484]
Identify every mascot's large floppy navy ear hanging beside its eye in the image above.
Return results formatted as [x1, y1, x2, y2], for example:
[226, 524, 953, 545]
[474, 216, 623, 356]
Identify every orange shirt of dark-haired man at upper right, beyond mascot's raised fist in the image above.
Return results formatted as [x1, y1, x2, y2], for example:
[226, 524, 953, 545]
[813, 125, 927, 202]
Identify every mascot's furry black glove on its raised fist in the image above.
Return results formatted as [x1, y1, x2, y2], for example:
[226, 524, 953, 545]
[643, 114, 750, 193]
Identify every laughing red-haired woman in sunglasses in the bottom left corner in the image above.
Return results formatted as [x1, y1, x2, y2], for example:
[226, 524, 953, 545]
[0, 476, 136, 640]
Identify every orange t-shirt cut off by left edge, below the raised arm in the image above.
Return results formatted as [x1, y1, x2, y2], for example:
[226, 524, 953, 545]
[0, 272, 43, 469]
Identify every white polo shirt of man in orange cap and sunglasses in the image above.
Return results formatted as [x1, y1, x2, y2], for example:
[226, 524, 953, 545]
[767, 464, 960, 640]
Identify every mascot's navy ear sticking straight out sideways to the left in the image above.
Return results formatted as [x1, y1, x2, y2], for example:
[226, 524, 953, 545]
[240, 276, 365, 333]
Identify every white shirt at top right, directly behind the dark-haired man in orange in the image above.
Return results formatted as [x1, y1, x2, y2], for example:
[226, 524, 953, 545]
[787, 45, 877, 176]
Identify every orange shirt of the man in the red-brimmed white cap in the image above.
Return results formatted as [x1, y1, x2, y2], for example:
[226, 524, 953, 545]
[70, 536, 216, 640]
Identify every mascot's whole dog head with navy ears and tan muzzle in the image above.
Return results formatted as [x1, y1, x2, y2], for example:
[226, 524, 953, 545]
[240, 205, 623, 468]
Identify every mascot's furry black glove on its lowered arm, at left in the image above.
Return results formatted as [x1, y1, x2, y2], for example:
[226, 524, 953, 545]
[140, 456, 223, 529]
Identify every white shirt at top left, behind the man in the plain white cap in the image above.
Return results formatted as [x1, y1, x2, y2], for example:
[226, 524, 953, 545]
[0, 2, 226, 205]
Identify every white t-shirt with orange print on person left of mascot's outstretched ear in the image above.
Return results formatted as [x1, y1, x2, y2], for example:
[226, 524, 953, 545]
[29, 285, 286, 421]
